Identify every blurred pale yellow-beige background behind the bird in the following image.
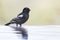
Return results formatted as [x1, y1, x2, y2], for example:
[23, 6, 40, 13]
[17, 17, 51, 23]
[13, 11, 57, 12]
[0, 0, 60, 25]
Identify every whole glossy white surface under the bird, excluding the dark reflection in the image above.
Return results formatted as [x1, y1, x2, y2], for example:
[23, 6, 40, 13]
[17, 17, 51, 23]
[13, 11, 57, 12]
[0, 25, 60, 40]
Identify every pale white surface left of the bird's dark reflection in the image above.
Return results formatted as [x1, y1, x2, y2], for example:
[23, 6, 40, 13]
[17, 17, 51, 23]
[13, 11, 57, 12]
[0, 26, 22, 40]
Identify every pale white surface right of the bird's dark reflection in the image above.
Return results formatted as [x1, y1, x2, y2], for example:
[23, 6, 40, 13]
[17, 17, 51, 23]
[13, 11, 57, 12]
[28, 26, 60, 40]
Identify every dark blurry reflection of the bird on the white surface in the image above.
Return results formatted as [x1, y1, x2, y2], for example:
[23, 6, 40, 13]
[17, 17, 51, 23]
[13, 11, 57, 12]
[10, 26, 28, 40]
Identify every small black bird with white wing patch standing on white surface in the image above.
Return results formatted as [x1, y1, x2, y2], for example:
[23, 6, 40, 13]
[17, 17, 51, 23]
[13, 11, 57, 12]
[5, 7, 30, 27]
